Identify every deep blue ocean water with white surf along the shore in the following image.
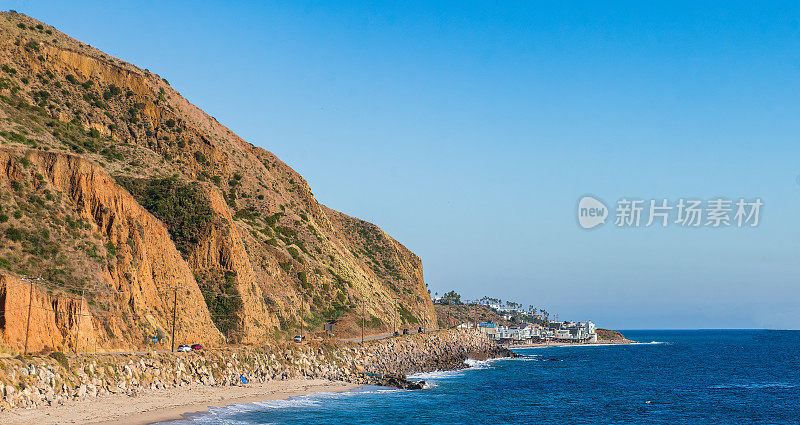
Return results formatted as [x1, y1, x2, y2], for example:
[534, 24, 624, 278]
[164, 330, 800, 425]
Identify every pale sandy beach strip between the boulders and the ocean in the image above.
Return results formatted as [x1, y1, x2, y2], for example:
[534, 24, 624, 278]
[0, 379, 358, 425]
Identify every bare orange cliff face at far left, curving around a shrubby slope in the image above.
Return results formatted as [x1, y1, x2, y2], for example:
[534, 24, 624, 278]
[0, 149, 221, 351]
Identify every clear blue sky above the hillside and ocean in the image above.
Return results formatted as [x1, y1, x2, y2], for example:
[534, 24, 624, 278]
[7, 0, 800, 329]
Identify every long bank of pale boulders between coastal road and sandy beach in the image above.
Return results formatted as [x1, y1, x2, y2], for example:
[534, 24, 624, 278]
[0, 331, 513, 411]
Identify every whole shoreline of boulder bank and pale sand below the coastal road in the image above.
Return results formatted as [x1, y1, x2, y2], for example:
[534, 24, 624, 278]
[0, 330, 514, 425]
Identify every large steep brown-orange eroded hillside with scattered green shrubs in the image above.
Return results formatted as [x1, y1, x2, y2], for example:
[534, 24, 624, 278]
[0, 13, 436, 352]
